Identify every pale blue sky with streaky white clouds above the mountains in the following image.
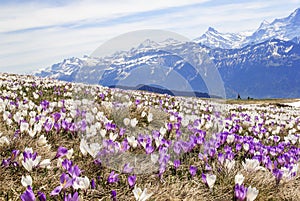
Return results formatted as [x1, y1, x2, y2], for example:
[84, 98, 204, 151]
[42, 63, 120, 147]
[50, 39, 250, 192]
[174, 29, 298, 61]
[0, 0, 300, 73]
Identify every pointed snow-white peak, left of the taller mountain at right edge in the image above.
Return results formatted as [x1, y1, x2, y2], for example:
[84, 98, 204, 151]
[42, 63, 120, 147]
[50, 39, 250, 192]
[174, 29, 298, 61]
[194, 27, 247, 49]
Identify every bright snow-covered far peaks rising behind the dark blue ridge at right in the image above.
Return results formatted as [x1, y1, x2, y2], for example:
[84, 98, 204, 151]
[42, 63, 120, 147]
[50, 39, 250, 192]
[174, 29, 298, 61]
[194, 8, 300, 49]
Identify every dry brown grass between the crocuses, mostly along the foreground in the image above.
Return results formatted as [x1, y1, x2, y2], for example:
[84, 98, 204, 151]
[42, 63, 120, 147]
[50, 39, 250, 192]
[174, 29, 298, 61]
[0, 98, 300, 201]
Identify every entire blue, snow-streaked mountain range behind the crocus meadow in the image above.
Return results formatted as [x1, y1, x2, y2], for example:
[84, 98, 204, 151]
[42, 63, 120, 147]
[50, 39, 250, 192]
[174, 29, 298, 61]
[35, 9, 300, 98]
